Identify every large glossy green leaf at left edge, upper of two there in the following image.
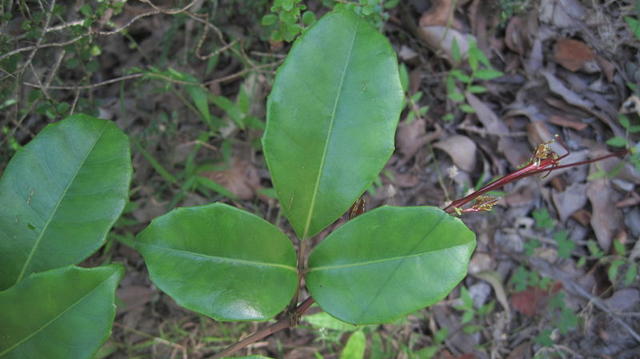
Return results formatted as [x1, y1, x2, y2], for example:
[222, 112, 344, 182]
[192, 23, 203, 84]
[0, 115, 131, 290]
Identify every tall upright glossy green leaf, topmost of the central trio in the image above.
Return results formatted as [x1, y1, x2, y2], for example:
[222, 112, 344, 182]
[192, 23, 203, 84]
[263, 10, 403, 238]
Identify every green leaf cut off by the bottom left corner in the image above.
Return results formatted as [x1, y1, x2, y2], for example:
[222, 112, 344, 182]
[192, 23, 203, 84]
[0, 265, 124, 359]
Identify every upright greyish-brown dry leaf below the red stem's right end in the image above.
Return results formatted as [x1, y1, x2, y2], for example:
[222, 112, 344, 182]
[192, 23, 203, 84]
[587, 179, 622, 252]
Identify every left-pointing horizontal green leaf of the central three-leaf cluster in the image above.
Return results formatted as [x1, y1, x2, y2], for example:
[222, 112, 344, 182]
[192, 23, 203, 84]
[136, 203, 298, 320]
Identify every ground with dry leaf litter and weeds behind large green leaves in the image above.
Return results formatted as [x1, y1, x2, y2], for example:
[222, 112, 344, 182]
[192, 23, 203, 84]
[0, 0, 640, 359]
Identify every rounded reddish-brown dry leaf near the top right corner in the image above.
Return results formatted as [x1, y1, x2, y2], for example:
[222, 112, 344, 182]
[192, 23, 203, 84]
[553, 38, 599, 72]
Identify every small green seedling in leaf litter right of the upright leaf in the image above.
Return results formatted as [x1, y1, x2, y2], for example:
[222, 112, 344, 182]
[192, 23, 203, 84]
[443, 39, 504, 121]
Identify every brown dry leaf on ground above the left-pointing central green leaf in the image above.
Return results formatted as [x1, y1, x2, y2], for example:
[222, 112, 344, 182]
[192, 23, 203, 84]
[200, 160, 260, 200]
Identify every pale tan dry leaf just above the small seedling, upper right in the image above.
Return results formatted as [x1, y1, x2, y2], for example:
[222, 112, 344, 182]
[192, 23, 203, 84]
[418, 26, 473, 64]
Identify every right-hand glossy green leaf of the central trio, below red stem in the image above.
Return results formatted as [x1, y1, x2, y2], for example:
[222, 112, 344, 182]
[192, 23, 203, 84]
[306, 207, 475, 324]
